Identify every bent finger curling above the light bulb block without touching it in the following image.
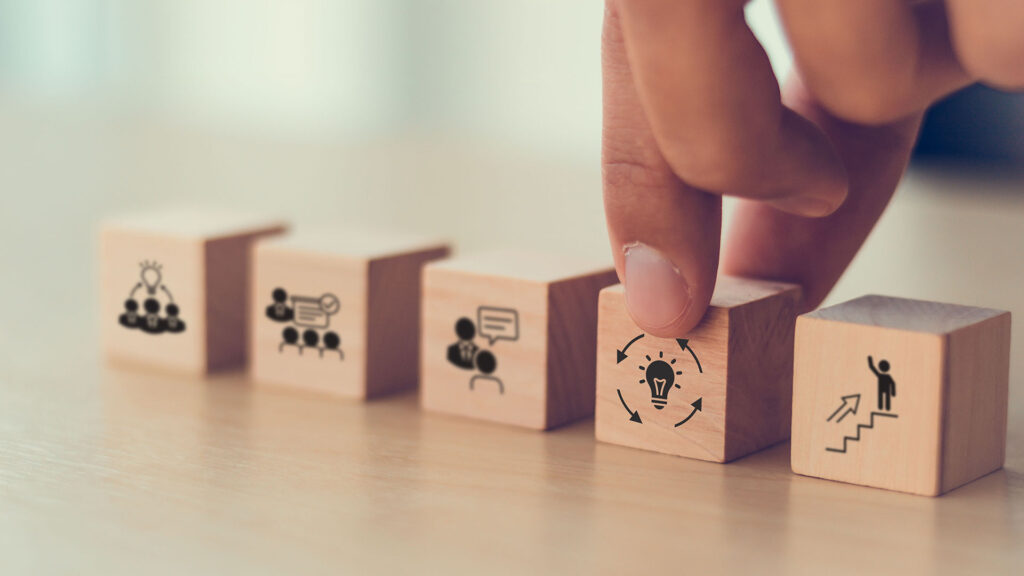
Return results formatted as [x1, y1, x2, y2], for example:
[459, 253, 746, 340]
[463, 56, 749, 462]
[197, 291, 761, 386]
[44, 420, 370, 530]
[617, 0, 846, 216]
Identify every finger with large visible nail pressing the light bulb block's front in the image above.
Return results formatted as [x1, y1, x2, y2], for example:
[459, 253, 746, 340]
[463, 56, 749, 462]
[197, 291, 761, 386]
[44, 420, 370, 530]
[602, 3, 722, 337]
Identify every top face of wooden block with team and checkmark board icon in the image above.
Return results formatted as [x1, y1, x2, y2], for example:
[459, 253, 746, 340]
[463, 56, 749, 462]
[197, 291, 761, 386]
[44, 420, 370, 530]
[259, 228, 447, 260]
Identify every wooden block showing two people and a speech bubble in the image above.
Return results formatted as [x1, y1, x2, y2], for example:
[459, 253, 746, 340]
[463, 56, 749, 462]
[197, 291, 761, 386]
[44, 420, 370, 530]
[421, 252, 616, 429]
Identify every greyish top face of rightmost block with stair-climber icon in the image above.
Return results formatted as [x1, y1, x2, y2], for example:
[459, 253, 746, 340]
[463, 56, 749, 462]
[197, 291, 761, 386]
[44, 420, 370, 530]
[802, 295, 1009, 334]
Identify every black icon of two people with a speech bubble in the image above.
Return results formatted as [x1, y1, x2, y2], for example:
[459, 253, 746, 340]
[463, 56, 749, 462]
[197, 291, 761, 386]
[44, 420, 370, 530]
[445, 306, 519, 394]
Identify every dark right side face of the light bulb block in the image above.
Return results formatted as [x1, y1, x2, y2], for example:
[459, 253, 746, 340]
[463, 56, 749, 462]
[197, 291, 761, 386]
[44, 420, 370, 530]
[725, 287, 801, 460]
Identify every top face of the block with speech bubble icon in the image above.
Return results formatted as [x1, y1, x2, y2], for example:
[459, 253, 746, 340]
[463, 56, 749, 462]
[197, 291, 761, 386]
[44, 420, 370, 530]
[427, 250, 612, 284]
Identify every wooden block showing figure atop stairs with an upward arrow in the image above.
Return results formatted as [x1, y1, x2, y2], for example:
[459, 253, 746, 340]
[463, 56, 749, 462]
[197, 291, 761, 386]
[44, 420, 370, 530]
[793, 296, 1010, 496]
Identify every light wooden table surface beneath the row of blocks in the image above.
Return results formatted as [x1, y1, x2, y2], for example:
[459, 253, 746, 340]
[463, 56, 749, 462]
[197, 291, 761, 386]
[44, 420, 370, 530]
[0, 105, 1024, 575]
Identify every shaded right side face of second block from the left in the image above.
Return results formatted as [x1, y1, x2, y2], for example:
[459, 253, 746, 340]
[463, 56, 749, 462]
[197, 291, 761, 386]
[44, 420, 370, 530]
[367, 247, 449, 397]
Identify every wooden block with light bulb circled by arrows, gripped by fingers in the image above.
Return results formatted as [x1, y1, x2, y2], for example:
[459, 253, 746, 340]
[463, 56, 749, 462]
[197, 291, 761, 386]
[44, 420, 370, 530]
[595, 276, 801, 462]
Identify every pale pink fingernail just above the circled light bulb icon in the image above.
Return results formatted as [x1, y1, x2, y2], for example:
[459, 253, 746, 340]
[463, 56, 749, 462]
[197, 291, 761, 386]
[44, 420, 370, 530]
[625, 243, 690, 329]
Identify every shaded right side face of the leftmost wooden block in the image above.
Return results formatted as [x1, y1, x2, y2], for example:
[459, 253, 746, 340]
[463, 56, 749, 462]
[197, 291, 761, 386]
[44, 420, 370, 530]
[204, 230, 279, 371]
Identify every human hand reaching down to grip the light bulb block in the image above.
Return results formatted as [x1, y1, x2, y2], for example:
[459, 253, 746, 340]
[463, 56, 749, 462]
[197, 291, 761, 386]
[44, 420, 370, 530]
[602, 0, 1024, 337]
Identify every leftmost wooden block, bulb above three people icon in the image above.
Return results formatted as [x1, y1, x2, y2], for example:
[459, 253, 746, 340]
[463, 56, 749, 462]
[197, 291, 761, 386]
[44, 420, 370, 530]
[99, 211, 285, 373]
